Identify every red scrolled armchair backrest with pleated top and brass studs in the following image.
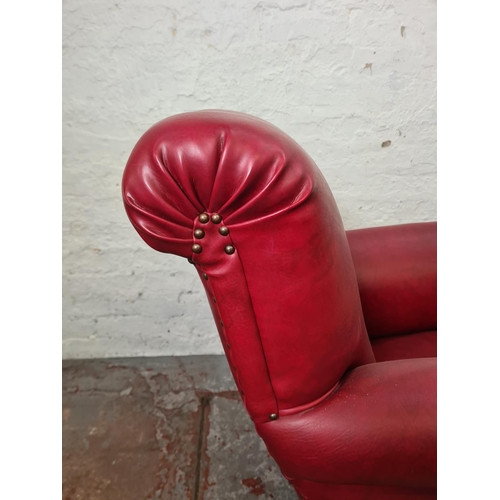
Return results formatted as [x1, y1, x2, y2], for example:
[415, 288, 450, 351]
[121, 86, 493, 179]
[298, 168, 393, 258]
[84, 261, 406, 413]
[123, 111, 374, 423]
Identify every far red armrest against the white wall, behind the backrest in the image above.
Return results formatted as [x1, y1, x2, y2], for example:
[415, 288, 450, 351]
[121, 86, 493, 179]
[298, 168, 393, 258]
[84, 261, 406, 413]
[346, 222, 437, 338]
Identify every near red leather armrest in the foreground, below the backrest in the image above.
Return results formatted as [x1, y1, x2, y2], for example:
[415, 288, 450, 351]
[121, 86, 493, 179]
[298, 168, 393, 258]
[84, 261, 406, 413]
[256, 358, 437, 488]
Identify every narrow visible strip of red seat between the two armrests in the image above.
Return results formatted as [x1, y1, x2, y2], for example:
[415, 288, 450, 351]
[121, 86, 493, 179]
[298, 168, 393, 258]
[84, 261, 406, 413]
[371, 330, 437, 361]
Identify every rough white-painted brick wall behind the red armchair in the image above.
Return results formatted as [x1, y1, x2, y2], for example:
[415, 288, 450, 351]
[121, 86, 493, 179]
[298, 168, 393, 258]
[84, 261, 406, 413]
[63, 0, 436, 358]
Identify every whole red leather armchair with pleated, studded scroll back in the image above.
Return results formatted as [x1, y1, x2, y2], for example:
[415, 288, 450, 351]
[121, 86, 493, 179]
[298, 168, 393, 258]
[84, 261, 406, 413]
[123, 111, 436, 500]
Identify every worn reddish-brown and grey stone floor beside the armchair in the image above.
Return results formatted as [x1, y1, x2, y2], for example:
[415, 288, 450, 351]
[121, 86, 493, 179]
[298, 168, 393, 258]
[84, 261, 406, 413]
[63, 356, 297, 500]
